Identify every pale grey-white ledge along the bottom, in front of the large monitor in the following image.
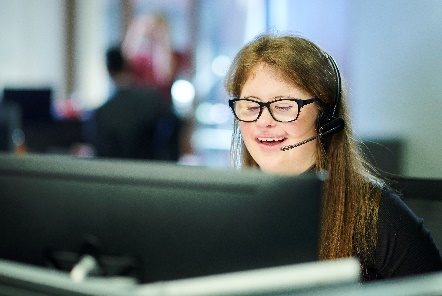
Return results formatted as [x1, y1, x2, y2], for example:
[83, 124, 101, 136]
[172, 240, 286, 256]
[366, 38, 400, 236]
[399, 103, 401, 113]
[0, 258, 360, 296]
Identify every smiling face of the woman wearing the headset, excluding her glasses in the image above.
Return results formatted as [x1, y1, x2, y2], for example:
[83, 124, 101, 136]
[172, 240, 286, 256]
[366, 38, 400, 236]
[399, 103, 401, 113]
[239, 64, 318, 175]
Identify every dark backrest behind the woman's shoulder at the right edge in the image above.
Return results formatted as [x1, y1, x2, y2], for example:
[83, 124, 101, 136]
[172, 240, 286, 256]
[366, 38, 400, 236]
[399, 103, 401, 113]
[392, 178, 442, 251]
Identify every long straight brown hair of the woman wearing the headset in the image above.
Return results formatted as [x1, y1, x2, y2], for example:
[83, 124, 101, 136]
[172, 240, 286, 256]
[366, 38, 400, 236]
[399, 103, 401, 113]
[225, 34, 381, 269]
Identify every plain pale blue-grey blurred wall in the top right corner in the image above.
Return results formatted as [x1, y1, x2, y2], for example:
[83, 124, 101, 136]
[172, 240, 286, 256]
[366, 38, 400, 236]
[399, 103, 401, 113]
[348, 0, 442, 178]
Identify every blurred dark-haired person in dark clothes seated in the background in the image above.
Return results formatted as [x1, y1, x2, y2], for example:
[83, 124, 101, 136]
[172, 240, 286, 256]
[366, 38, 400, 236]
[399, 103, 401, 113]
[89, 46, 181, 161]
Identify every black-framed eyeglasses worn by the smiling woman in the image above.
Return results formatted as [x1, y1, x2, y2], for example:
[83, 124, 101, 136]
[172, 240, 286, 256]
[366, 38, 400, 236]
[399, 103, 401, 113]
[229, 98, 319, 122]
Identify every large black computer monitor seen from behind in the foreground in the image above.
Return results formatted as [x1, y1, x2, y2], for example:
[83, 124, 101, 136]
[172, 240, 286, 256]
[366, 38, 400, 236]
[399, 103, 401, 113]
[0, 154, 321, 283]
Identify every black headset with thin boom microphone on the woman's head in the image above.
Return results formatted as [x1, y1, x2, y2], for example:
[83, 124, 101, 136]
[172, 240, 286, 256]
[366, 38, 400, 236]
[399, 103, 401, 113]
[281, 55, 345, 151]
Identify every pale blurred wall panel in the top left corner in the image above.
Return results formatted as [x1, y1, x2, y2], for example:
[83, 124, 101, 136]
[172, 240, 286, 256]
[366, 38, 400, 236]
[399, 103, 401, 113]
[0, 0, 65, 99]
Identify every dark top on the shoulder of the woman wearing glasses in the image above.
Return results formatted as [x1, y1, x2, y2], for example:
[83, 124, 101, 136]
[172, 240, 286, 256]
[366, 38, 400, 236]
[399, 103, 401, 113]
[363, 190, 442, 281]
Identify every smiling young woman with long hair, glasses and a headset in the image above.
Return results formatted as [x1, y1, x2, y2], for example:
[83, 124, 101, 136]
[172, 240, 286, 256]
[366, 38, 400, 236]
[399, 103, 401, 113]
[226, 35, 442, 280]
